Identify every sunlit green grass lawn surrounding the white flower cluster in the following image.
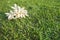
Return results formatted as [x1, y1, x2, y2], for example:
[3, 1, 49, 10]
[0, 0, 60, 40]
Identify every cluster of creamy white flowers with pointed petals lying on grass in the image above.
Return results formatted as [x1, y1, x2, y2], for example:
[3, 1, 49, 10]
[5, 4, 28, 20]
